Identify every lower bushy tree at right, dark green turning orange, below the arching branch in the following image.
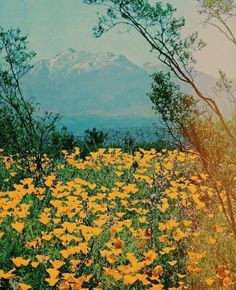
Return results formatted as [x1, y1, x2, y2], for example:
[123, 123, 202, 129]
[149, 72, 236, 237]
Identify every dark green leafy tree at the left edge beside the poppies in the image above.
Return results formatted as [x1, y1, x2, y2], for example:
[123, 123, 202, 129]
[0, 27, 58, 171]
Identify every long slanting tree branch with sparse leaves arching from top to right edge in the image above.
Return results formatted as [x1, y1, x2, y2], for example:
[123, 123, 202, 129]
[84, 0, 236, 145]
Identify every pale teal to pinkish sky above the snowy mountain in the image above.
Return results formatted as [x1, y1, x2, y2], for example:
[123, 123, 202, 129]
[0, 0, 236, 78]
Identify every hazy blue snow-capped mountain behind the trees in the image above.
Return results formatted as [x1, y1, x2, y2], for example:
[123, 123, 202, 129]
[23, 48, 234, 131]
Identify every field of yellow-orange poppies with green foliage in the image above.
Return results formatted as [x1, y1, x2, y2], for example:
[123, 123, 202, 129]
[0, 148, 236, 290]
